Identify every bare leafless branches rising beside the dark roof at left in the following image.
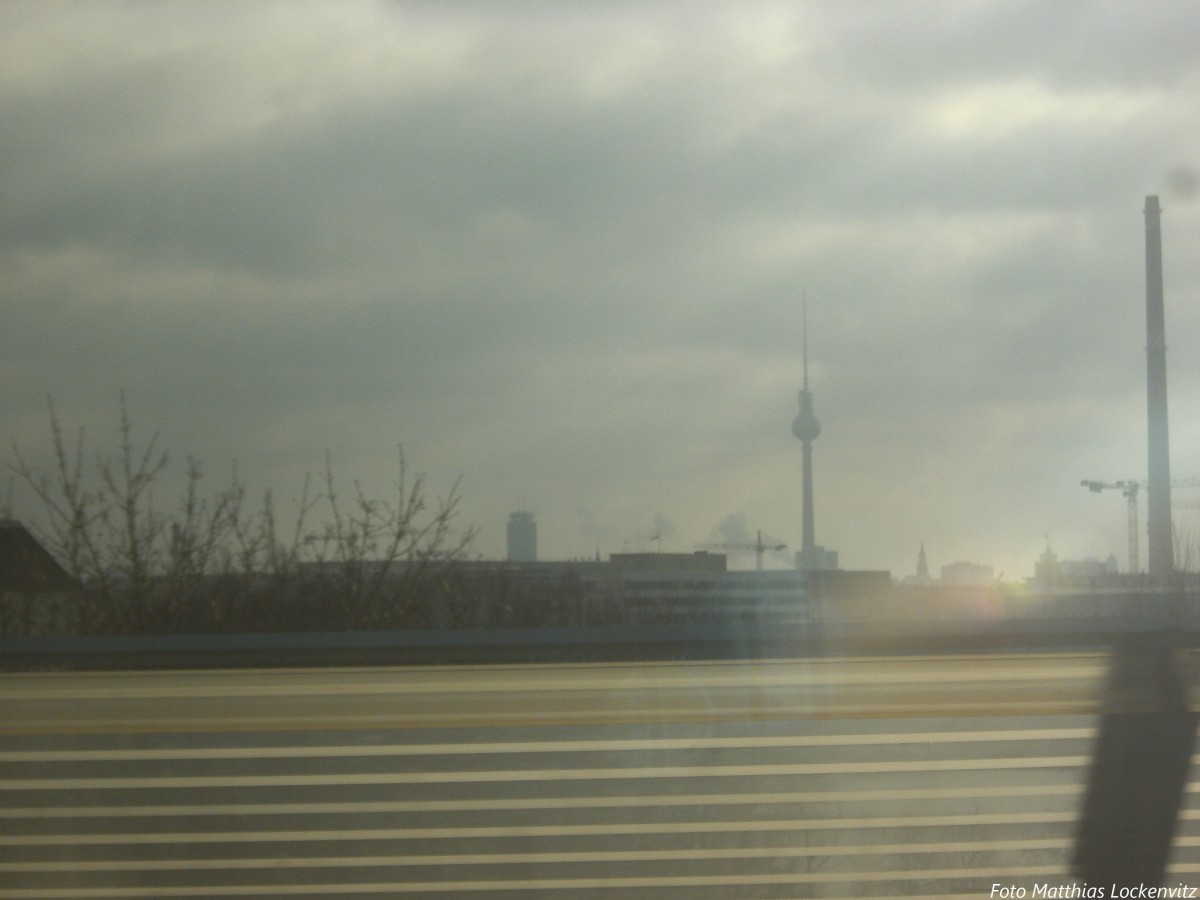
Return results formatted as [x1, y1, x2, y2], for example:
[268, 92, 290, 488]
[8, 395, 475, 634]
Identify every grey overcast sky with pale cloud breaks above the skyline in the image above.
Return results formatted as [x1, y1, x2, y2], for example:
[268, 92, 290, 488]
[0, 0, 1200, 580]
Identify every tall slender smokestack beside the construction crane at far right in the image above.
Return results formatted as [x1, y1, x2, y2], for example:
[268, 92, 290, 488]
[1146, 197, 1175, 580]
